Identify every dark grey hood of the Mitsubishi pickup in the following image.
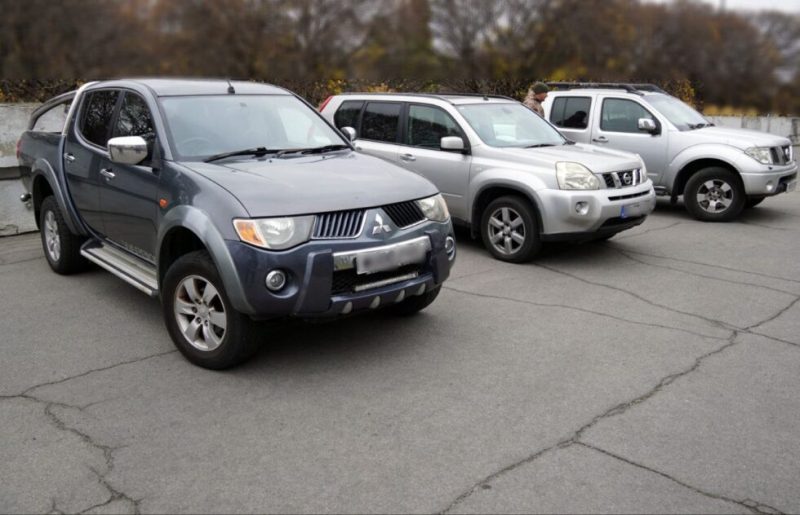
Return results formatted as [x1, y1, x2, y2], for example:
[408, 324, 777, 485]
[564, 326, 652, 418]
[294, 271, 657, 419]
[182, 152, 438, 217]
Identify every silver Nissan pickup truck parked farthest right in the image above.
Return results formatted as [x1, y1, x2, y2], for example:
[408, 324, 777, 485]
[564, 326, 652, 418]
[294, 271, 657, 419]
[544, 83, 797, 222]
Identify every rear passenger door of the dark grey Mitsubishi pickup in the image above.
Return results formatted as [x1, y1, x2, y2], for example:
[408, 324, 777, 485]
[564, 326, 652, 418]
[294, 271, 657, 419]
[64, 89, 121, 235]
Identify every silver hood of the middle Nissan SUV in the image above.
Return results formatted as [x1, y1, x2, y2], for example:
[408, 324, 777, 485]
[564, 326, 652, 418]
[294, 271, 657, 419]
[482, 143, 641, 173]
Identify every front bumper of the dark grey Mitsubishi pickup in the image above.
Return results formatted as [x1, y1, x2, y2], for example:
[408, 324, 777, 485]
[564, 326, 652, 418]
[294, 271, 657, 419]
[226, 222, 455, 319]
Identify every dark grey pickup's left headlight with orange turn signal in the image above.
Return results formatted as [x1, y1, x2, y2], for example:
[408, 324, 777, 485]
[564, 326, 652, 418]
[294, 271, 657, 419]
[233, 216, 314, 250]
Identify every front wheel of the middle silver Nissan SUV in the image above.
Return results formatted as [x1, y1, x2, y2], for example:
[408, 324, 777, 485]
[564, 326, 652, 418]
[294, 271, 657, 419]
[481, 196, 542, 263]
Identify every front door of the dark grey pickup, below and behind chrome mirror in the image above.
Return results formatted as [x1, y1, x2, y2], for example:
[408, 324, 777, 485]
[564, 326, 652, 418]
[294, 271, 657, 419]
[100, 91, 159, 263]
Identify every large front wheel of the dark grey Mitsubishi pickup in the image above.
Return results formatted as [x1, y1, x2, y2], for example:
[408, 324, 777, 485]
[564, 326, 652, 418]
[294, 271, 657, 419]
[161, 250, 258, 370]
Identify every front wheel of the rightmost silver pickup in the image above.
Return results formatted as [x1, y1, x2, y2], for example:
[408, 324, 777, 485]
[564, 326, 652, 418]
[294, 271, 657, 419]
[683, 167, 747, 222]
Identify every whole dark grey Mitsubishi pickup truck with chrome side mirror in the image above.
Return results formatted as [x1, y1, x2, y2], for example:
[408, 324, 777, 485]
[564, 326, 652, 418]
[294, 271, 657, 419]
[17, 79, 456, 369]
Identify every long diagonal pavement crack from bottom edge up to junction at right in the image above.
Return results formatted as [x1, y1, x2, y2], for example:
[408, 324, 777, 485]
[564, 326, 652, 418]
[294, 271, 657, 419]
[438, 331, 739, 514]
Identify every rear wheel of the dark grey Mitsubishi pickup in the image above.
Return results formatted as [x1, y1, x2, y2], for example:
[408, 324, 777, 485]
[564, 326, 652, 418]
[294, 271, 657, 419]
[39, 195, 88, 275]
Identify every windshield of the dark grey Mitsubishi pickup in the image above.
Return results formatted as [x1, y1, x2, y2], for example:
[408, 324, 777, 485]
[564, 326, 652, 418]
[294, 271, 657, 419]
[161, 95, 347, 160]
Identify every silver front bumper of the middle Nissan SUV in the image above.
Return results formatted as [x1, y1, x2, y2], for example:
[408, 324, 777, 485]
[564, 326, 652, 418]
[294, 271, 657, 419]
[537, 181, 656, 241]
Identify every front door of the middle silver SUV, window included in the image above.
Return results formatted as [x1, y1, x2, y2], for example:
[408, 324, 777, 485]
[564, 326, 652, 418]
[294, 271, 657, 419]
[397, 104, 472, 220]
